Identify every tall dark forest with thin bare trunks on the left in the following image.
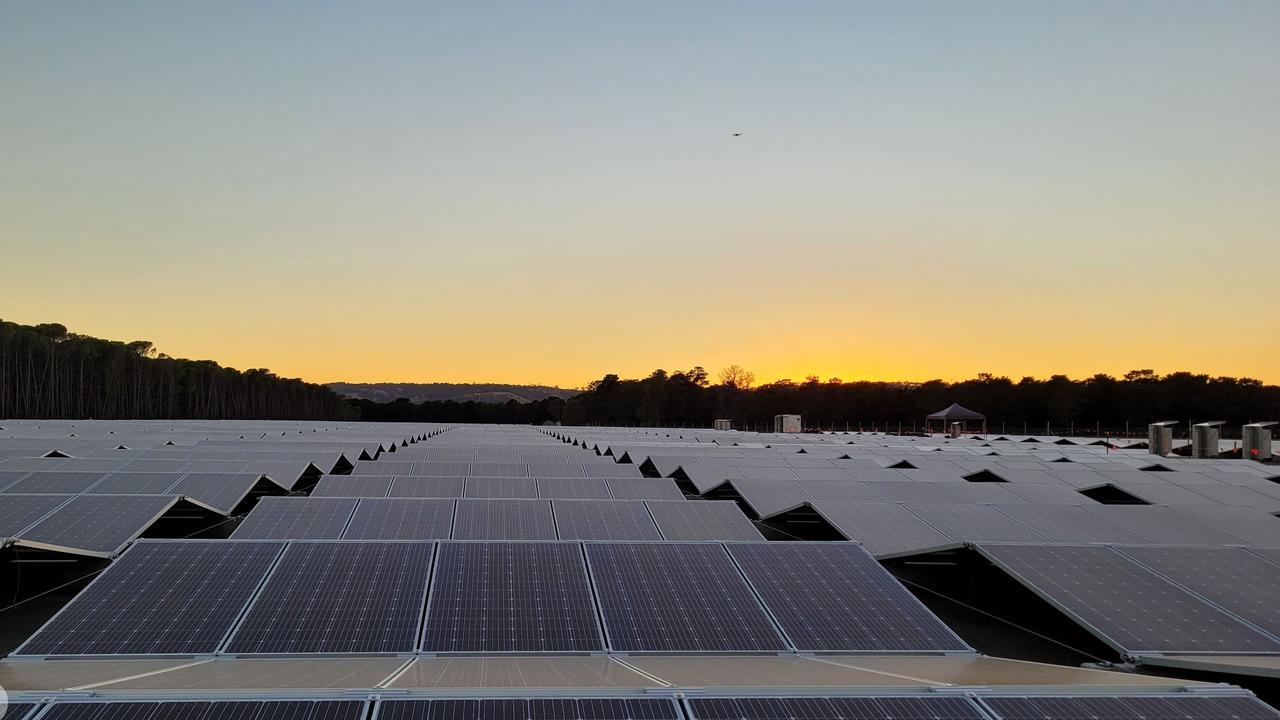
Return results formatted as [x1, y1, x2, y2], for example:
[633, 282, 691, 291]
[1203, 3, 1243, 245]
[0, 320, 357, 420]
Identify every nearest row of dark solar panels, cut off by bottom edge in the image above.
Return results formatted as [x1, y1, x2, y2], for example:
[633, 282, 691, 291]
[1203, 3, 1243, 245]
[4, 693, 1280, 720]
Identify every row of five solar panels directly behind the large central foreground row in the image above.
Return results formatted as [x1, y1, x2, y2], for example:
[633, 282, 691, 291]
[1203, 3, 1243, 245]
[232, 497, 763, 541]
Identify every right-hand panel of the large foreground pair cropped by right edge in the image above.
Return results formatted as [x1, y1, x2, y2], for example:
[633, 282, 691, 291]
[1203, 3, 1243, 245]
[1116, 547, 1280, 635]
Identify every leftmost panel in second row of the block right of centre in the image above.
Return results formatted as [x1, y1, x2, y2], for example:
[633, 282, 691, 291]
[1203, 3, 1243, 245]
[815, 502, 956, 557]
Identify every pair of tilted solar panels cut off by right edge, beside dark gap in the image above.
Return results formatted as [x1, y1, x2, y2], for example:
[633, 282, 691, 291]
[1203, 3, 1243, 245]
[978, 544, 1280, 655]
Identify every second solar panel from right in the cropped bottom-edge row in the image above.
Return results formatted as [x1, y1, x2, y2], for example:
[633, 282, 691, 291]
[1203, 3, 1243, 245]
[687, 697, 977, 720]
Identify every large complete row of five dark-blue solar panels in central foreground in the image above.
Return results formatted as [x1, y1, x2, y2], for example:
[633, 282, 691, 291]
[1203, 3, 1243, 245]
[17, 541, 969, 656]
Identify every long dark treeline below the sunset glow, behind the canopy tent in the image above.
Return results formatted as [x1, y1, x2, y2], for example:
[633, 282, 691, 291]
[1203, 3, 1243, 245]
[357, 366, 1280, 433]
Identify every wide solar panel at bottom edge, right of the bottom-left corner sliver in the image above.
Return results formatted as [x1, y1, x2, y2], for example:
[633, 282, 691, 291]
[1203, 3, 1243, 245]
[44, 700, 365, 720]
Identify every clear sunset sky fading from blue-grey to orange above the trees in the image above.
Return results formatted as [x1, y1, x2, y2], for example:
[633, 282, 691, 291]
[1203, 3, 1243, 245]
[0, 0, 1280, 387]
